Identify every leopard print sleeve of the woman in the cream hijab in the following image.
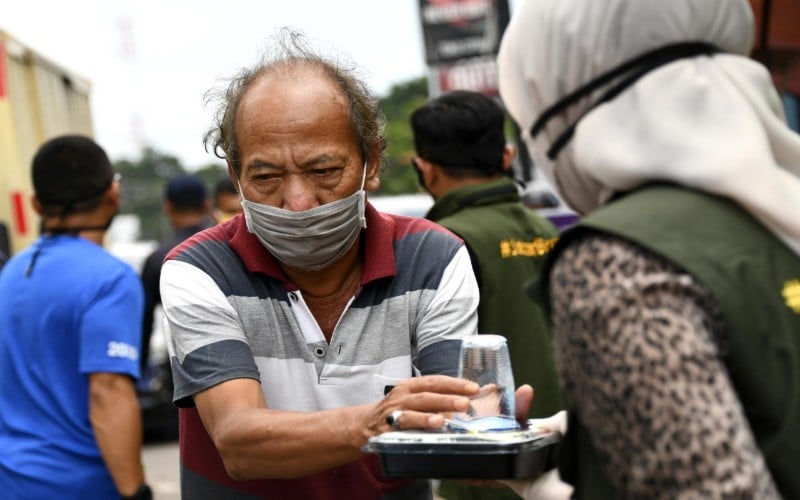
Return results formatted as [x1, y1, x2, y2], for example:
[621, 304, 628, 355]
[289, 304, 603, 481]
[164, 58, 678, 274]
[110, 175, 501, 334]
[551, 234, 780, 499]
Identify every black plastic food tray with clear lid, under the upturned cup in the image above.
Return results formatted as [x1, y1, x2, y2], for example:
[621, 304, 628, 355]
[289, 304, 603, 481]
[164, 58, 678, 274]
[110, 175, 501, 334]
[364, 422, 561, 479]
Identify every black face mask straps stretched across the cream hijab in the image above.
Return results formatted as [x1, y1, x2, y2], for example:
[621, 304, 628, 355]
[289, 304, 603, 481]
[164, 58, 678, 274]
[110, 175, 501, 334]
[530, 42, 720, 160]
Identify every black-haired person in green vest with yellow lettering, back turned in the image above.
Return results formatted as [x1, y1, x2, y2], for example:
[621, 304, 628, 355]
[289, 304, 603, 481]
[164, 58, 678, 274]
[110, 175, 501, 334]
[410, 90, 562, 499]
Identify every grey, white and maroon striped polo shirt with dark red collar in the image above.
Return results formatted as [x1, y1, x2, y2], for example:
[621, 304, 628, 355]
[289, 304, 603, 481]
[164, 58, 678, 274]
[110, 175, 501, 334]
[161, 204, 478, 498]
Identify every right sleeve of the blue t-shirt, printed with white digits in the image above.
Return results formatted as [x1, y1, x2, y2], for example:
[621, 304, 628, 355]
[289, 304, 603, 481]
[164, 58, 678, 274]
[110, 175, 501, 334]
[80, 263, 144, 378]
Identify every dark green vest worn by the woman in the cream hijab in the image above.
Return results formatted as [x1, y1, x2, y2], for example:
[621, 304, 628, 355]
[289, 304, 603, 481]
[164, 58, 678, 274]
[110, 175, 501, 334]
[540, 185, 800, 499]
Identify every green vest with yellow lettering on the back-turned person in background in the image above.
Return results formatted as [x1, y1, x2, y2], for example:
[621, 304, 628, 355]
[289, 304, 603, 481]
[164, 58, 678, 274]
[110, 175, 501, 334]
[426, 178, 564, 500]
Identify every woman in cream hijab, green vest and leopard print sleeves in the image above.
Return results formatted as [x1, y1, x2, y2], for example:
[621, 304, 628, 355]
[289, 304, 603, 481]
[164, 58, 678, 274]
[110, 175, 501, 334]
[498, 0, 800, 499]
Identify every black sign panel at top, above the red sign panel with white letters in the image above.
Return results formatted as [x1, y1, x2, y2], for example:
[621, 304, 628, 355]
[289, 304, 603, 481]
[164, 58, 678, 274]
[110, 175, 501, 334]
[419, 0, 509, 65]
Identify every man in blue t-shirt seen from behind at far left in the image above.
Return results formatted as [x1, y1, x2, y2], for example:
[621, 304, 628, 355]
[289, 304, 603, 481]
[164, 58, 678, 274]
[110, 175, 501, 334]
[0, 135, 151, 499]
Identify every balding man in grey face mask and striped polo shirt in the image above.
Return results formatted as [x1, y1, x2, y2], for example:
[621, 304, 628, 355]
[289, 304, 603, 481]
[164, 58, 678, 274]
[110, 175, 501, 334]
[161, 30, 478, 499]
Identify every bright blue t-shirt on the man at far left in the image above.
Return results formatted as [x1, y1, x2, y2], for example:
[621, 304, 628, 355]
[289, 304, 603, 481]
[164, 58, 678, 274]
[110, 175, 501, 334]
[0, 236, 143, 499]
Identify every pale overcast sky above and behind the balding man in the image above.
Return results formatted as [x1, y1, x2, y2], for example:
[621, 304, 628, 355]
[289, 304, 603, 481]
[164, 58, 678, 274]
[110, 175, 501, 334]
[0, 0, 440, 168]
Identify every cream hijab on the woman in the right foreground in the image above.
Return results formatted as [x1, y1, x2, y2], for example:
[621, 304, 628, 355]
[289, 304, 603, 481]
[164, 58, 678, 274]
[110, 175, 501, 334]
[498, 0, 800, 255]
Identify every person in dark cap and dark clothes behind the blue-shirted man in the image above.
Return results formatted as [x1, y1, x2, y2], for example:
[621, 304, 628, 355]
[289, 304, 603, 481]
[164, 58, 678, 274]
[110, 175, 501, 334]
[141, 174, 210, 375]
